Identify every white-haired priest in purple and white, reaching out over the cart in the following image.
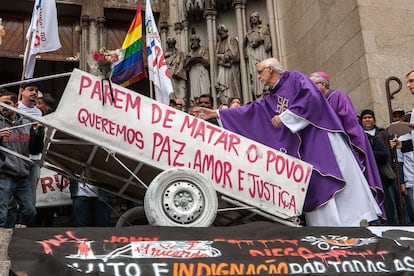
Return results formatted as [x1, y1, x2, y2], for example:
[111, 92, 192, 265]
[193, 58, 382, 226]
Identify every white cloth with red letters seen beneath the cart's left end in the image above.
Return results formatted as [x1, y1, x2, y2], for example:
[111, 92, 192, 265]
[36, 168, 72, 207]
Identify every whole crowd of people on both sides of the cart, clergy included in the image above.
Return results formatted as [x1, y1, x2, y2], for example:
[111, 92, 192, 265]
[0, 58, 414, 227]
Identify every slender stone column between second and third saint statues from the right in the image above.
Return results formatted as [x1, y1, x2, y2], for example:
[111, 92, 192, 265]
[203, 8, 217, 108]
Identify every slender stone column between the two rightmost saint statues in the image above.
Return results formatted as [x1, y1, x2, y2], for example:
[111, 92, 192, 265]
[233, 0, 252, 103]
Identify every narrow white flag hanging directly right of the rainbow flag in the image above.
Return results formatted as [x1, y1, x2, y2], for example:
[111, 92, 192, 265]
[145, 0, 173, 105]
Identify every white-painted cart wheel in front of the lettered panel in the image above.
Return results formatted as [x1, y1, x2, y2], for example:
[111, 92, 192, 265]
[144, 168, 218, 227]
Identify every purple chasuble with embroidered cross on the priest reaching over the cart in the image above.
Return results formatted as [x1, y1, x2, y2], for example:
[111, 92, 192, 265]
[219, 71, 348, 212]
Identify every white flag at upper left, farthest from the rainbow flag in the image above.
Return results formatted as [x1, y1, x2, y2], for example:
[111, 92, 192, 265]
[24, 0, 61, 79]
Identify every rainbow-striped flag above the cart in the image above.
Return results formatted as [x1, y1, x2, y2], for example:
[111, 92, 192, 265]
[112, 4, 147, 87]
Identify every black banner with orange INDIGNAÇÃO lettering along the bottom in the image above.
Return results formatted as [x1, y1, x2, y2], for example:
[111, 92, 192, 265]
[9, 222, 414, 276]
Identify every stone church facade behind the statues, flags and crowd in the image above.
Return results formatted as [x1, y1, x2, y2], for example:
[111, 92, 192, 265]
[0, 0, 414, 126]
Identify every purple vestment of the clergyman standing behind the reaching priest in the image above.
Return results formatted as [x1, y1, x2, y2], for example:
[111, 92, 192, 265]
[325, 89, 385, 210]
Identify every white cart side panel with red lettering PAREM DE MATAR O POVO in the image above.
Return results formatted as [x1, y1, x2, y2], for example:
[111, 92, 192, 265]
[51, 69, 312, 218]
